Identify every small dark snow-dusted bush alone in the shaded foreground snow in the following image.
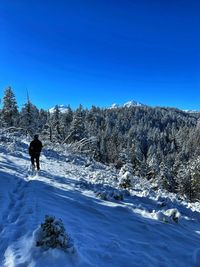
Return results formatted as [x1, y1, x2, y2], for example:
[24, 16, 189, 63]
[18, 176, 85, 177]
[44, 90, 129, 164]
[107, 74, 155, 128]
[35, 215, 73, 250]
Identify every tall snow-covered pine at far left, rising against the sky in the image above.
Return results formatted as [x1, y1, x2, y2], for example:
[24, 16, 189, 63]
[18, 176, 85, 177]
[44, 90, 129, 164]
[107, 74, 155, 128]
[1, 86, 19, 128]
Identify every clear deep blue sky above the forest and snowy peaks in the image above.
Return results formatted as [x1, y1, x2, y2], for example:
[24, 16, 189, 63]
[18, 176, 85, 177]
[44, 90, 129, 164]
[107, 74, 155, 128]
[0, 0, 200, 109]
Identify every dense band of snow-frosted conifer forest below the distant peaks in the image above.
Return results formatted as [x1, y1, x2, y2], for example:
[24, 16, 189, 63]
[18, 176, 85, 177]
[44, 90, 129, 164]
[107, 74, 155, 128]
[0, 87, 200, 200]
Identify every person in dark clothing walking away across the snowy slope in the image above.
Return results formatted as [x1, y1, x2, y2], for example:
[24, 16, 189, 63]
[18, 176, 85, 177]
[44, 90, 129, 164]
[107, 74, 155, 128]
[29, 134, 42, 171]
